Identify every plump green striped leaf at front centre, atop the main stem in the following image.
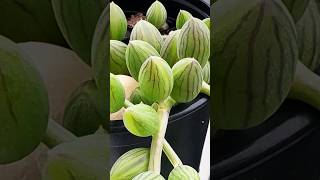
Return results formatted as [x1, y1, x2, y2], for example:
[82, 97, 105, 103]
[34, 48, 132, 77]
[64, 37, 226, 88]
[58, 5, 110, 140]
[139, 56, 173, 102]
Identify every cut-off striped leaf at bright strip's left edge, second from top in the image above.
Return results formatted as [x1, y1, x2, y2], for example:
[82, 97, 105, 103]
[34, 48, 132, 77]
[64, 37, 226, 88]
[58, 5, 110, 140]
[110, 40, 129, 74]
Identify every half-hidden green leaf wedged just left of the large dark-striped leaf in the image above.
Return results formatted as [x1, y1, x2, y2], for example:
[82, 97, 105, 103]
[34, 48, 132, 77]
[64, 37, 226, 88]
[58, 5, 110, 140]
[160, 30, 180, 67]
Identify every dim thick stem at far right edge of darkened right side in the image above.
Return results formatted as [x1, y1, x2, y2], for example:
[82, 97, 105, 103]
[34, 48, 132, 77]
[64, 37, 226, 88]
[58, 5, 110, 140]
[289, 61, 320, 110]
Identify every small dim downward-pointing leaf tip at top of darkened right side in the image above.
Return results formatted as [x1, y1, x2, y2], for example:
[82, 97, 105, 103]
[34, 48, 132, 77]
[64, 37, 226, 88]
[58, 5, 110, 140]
[282, 0, 310, 22]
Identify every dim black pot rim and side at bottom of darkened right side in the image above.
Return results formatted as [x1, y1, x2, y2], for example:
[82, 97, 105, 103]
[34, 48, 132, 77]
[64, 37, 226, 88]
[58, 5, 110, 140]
[211, 69, 320, 180]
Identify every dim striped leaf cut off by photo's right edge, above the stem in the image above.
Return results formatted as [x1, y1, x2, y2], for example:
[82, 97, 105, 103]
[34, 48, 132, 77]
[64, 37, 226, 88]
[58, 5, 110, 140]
[296, 0, 320, 70]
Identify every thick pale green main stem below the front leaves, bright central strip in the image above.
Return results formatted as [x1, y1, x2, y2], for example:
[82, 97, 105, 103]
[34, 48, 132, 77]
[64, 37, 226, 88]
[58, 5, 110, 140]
[148, 97, 175, 174]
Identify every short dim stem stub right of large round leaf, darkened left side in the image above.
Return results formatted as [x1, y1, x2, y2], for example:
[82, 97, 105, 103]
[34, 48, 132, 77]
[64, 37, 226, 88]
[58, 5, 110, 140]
[42, 119, 77, 148]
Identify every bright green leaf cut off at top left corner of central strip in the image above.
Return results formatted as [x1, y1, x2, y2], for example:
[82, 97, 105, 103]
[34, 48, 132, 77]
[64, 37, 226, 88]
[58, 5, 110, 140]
[110, 2, 127, 41]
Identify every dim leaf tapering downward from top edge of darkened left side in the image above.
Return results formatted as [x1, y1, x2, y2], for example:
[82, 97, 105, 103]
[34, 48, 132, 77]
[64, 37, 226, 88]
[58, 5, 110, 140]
[52, 0, 106, 64]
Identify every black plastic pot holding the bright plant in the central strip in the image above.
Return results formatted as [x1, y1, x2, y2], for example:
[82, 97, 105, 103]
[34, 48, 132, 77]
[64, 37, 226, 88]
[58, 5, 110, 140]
[110, 0, 210, 177]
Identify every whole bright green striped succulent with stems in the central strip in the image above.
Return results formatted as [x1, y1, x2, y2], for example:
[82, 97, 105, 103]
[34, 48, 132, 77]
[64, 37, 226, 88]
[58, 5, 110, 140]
[110, 1, 210, 180]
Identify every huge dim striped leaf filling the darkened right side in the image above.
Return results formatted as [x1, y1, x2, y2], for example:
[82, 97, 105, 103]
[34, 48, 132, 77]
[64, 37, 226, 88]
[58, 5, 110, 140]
[211, 0, 298, 129]
